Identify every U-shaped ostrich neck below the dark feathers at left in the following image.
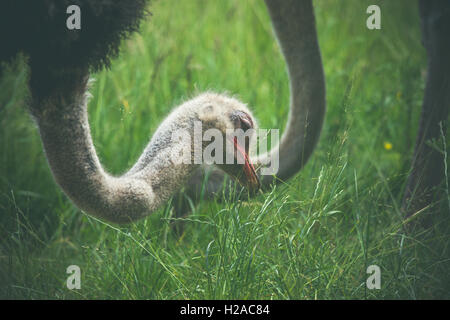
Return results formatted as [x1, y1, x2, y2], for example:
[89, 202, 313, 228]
[31, 74, 195, 223]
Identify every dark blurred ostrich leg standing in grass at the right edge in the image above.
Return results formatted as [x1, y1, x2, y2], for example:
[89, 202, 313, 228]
[402, 0, 450, 226]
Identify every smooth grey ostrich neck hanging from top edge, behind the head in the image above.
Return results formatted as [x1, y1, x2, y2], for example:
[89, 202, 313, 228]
[257, 0, 326, 186]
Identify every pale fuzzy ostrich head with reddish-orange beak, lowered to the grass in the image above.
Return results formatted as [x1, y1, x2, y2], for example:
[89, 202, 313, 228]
[145, 92, 260, 191]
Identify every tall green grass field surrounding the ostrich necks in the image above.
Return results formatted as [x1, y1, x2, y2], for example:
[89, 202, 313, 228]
[0, 0, 450, 299]
